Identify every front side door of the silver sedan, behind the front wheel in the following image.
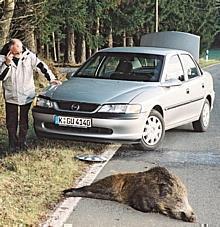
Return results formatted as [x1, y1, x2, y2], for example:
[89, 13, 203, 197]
[162, 54, 188, 129]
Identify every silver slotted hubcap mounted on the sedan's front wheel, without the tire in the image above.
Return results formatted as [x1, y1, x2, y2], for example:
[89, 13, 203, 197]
[142, 116, 163, 146]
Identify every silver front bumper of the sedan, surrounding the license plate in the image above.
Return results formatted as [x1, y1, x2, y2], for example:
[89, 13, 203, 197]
[32, 107, 147, 143]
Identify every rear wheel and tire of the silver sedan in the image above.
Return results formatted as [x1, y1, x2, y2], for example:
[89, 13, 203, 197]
[192, 99, 210, 132]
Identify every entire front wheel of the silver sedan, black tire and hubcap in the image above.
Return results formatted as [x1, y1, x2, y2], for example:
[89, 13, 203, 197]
[136, 110, 165, 151]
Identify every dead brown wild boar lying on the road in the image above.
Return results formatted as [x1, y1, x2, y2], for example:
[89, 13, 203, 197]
[63, 167, 196, 222]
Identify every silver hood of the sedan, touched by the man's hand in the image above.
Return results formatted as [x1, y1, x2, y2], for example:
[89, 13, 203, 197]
[44, 77, 157, 104]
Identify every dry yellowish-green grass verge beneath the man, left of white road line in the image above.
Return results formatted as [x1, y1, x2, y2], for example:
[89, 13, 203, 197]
[0, 69, 107, 227]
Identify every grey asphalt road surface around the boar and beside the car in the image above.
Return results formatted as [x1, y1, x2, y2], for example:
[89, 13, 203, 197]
[66, 65, 220, 227]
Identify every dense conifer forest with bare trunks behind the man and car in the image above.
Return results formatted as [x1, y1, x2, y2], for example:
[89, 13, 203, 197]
[0, 0, 220, 65]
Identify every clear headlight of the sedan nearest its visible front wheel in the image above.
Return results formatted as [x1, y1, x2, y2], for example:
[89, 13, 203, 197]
[99, 104, 141, 113]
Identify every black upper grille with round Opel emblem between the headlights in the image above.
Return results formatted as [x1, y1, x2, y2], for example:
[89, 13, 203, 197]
[57, 101, 99, 112]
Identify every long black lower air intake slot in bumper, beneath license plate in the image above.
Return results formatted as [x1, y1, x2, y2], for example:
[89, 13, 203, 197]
[44, 123, 113, 135]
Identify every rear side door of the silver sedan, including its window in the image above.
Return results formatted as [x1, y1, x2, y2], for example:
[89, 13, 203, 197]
[180, 54, 205, 119]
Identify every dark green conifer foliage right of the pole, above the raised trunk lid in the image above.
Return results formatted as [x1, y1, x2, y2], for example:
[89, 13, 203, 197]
[159, 0, 219, 52]
